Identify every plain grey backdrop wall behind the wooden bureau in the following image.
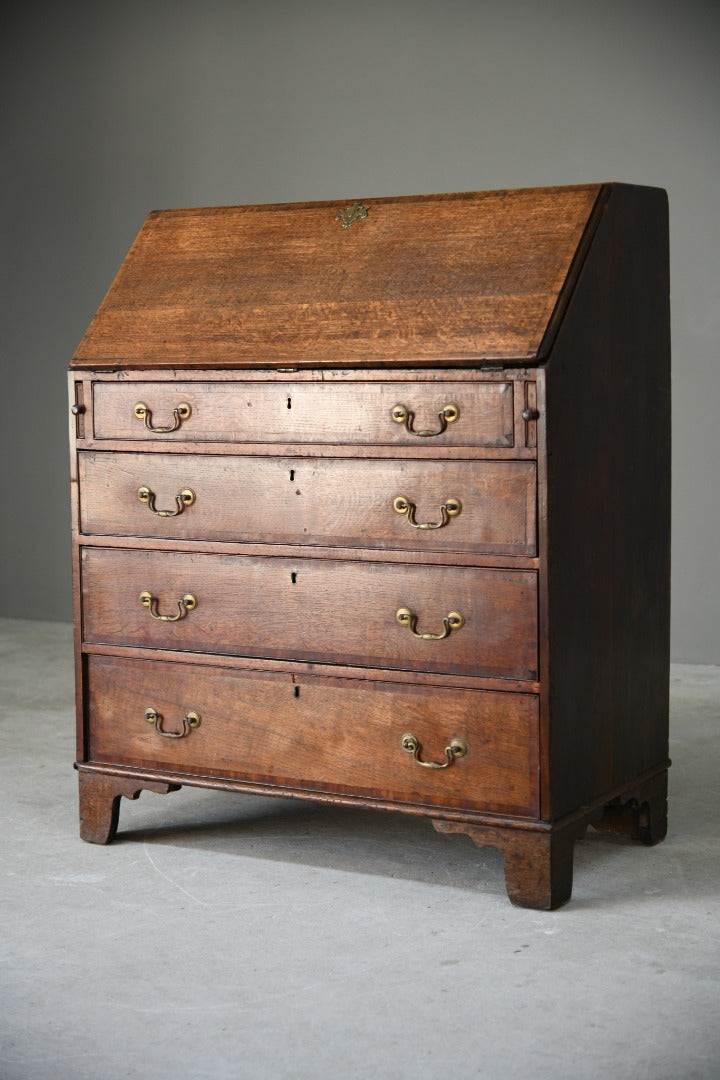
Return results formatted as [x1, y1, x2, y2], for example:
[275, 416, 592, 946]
[0, 0, 720, 663]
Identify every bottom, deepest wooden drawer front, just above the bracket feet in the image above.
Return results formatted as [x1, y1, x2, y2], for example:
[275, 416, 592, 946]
[87, 656, 539, 814]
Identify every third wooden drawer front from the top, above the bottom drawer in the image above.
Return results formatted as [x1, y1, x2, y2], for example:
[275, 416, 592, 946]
[82, 548, 538, 679]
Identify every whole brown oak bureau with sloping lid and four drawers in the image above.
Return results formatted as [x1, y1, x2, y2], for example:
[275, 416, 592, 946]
[69, 184, 670, 908]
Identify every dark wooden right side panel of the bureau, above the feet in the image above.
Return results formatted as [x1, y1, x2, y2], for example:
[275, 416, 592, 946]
[541, 185, 670, 818]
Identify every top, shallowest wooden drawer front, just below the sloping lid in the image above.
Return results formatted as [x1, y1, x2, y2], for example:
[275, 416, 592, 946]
[93, 380, 514, 447]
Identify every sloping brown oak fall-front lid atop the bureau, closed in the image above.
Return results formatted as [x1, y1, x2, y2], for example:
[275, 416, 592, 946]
[73, 185, 601, 368]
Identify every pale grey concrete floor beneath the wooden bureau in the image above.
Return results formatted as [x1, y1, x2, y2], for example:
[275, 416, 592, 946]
[0, 620, 720, 1080]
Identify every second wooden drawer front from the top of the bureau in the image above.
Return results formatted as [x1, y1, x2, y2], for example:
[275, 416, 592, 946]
[79, 451, 535, 555]
